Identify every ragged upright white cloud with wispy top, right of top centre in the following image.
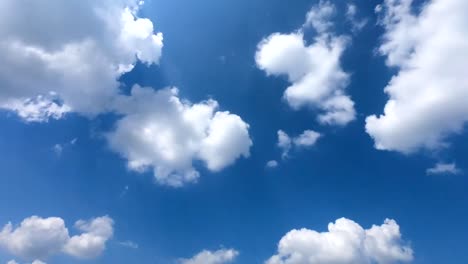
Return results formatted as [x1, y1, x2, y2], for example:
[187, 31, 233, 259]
[255, 1, 356, 125]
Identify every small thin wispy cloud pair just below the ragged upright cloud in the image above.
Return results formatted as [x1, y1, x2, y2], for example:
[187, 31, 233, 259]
[277, 130, 321, 159]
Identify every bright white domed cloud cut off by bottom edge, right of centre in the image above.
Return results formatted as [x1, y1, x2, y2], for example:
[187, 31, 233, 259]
[266, 218, 413, 264]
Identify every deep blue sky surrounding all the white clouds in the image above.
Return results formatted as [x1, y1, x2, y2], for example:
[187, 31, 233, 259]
[0, 0, 468, 264]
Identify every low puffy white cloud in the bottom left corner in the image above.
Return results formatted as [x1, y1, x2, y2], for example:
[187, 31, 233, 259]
[0, 216, 114, 263]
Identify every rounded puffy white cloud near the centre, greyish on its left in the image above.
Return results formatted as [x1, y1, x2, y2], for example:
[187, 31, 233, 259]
[108, 86, 252, 187]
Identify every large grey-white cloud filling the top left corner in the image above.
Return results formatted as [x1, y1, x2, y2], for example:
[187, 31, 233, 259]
[0, 0, 163, 121]
